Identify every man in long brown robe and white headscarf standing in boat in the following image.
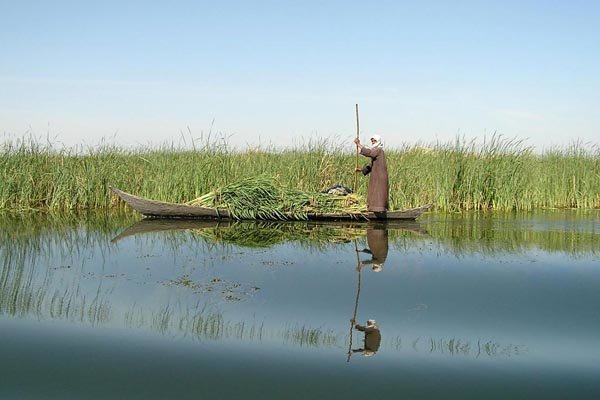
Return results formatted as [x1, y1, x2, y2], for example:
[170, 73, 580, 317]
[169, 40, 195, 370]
[354, 135, 389, 213]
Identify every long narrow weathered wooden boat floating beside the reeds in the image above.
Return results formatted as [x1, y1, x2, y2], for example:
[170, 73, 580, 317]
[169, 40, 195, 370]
[110, 187, 432, 221]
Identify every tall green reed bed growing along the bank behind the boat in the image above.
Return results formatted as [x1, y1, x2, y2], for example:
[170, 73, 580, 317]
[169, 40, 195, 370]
[0, 136, 600, 211]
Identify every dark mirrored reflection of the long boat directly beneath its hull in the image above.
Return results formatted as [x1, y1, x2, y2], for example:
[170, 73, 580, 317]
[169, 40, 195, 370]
[111, 218, 427, 243]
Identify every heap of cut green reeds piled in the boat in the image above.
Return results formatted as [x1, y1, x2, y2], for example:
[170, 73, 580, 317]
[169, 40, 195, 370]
[187, 175, 367, 220]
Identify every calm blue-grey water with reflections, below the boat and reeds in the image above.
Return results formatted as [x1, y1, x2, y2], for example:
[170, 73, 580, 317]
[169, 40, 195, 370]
[0, 211, 600, 399]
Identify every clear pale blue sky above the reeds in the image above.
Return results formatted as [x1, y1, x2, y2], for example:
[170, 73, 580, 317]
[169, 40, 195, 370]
[0, 0, 600, 150]
